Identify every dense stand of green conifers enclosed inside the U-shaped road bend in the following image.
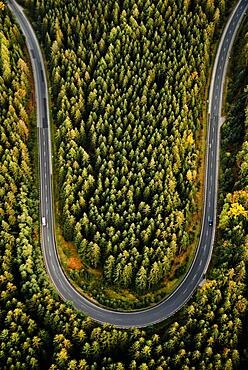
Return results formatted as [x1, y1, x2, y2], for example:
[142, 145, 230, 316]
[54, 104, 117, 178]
[20, 0, 225, 291]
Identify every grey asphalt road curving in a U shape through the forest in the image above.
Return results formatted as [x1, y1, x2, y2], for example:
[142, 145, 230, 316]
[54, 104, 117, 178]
[8, 0, 248, 327]
